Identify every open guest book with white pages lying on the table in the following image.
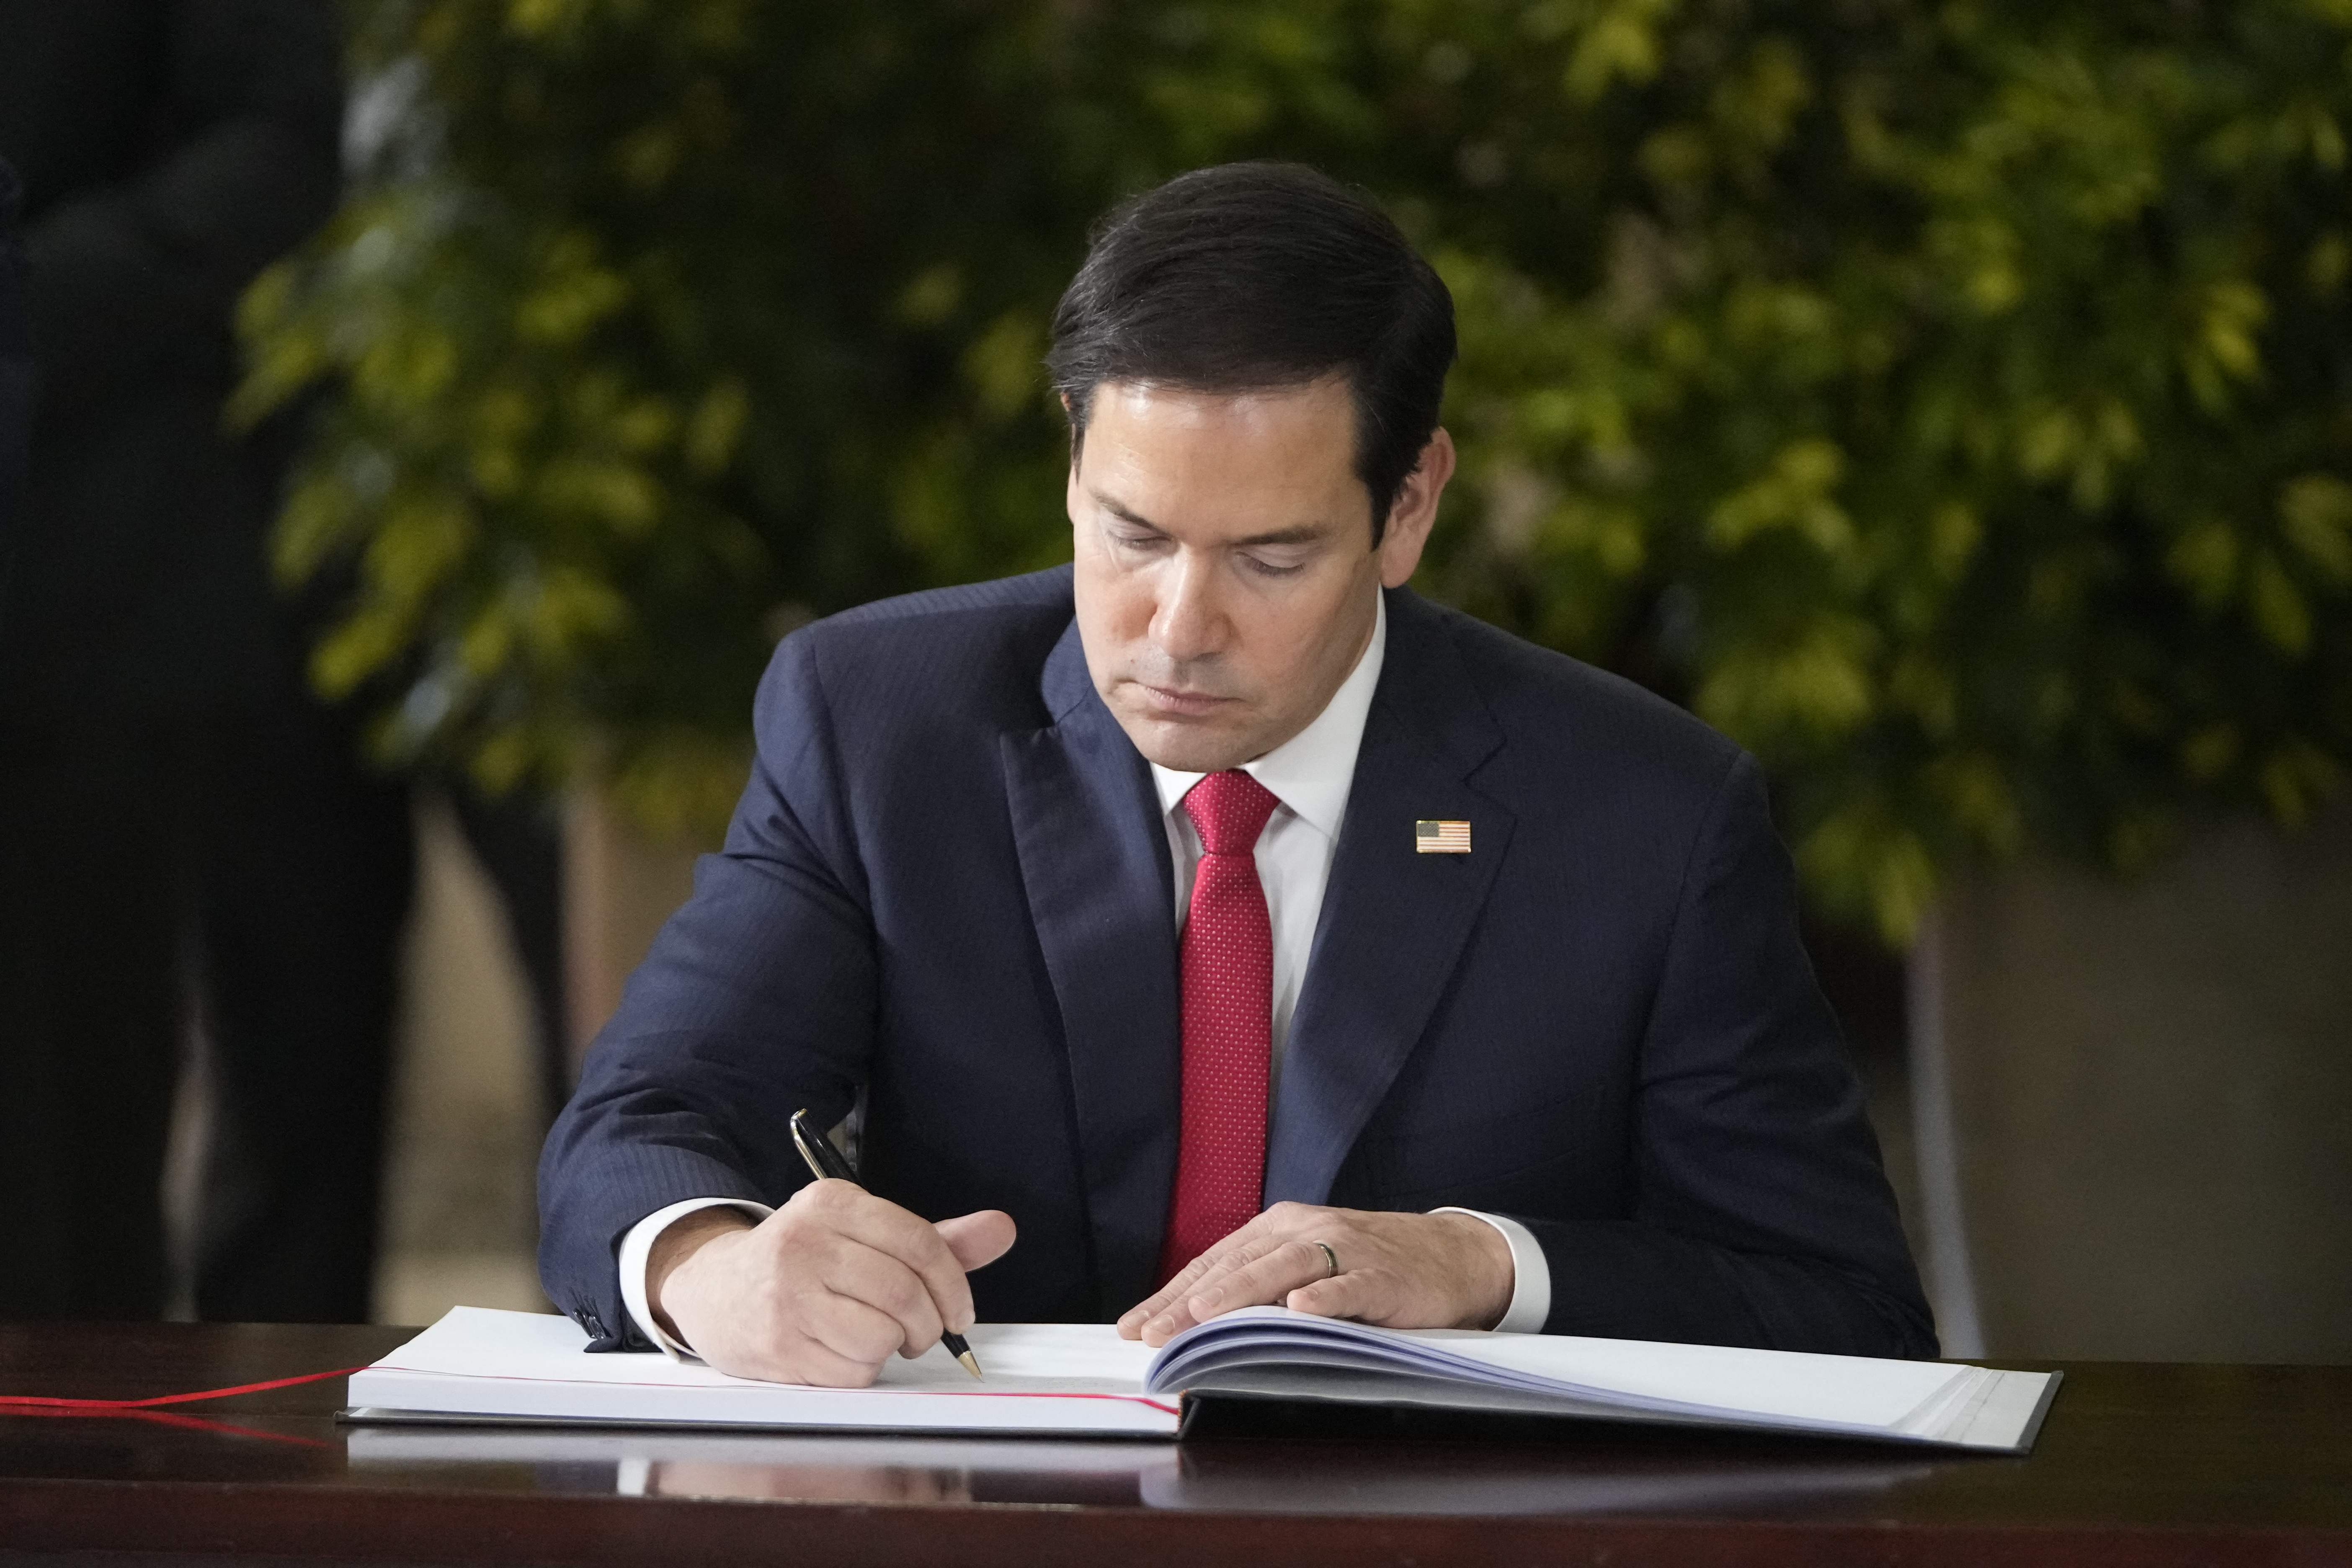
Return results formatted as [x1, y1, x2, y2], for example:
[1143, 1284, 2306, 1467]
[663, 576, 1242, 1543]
[346, 1307, 2058, 1453]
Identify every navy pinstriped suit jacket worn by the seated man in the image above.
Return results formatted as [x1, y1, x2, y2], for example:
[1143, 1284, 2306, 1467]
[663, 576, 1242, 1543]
[539, 567, 1936, 1357]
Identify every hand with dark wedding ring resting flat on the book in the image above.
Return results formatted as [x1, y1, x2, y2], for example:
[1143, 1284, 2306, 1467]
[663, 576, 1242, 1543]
[1119, 1204, 1515, 1345]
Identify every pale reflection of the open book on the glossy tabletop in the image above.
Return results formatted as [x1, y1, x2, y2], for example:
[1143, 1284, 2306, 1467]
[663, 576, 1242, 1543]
[346, 1427, 1936, 1516]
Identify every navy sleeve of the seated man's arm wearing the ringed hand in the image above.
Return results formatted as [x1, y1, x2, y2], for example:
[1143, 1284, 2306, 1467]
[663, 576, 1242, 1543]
[1522, 755, 1936, 1357]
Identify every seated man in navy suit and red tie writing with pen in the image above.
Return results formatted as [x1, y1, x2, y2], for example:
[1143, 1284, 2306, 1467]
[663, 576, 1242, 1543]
[541, 165, 1936, 1385]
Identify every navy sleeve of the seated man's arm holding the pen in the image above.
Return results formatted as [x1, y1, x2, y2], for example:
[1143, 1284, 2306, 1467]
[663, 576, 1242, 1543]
[539, 632, 875, 1349]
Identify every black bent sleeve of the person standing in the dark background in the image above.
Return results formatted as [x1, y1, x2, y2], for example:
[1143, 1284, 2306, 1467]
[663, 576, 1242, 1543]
[26, 0, 343, 418]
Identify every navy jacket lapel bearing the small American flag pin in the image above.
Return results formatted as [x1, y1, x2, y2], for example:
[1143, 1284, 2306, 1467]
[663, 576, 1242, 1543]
[1265, 590, 1512, 1204]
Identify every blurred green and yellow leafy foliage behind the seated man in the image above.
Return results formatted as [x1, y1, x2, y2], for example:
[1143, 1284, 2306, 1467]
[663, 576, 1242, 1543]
[240, 0, 2352, 938]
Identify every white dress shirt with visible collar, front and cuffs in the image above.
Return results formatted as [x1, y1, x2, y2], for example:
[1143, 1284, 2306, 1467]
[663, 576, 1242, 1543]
[619, 602, 1553, 1357]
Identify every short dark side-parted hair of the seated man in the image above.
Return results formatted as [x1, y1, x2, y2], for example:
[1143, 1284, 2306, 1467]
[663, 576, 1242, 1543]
[1044, 162, 1454, 543]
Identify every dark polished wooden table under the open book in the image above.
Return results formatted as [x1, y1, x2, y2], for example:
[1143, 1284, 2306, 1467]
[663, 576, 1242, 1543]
[0, 1326, 2352, 1568]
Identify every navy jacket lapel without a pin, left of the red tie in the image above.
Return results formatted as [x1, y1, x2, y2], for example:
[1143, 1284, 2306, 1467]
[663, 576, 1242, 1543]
[1002, 623, 1181, 1314]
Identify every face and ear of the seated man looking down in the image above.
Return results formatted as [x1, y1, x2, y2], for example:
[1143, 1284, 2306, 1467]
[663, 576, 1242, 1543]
[1070, 381, 1454, 774]
